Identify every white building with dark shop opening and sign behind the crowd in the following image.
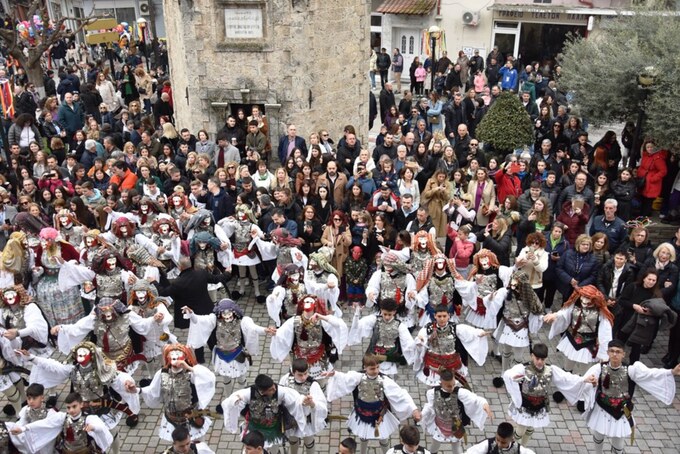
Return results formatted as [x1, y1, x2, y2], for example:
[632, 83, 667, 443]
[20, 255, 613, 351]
[371, 0, 631, 80]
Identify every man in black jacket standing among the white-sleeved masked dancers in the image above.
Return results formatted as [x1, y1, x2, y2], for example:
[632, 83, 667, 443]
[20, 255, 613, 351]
[158, 257, 231, 363]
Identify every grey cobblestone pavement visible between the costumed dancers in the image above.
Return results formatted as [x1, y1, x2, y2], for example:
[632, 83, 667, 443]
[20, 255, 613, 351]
[15, 283, 680, 454]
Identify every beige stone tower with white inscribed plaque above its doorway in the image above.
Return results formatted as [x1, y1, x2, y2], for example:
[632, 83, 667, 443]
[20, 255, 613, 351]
[163, 0, 370, 147]
